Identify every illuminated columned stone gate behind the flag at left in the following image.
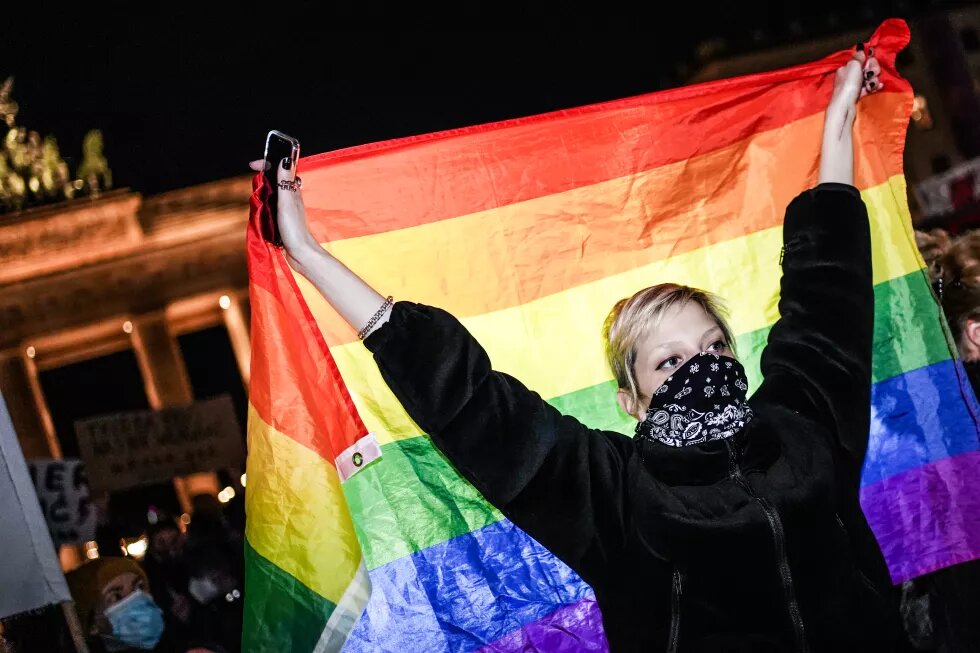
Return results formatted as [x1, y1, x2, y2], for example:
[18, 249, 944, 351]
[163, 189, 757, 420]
[0, 178, 250, 564]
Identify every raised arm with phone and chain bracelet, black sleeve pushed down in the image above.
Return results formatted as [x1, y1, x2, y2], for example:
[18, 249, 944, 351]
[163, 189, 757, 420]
[252, 161, 631, 578]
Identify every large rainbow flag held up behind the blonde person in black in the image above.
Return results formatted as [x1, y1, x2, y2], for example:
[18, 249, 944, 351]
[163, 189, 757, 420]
[244, 21, 980, 653]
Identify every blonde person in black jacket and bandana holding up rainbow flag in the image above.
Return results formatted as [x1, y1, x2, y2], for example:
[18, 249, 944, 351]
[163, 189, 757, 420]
[252, 46, 901, 651]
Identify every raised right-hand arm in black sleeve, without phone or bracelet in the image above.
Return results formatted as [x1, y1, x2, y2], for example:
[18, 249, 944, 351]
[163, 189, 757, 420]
[753, 51, 881, 466]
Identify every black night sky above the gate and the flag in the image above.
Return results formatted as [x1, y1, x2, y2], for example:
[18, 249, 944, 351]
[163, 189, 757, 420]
[0, 0, 969, 194]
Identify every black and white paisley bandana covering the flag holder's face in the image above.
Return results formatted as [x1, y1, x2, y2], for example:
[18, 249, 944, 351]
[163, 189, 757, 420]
[636, 352, 753, 447]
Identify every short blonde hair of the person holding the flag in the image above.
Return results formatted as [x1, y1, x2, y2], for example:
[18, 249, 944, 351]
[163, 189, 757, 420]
[603, 283, 735, 405]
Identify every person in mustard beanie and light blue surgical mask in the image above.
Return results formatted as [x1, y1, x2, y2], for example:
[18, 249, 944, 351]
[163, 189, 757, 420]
[67, 558, 218, 653]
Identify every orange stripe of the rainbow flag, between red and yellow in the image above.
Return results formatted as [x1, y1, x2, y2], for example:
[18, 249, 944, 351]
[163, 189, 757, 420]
[296, 94, 904, 346]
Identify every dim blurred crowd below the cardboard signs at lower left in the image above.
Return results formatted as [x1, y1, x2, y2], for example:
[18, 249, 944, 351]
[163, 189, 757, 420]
[0, 494, 245, 653]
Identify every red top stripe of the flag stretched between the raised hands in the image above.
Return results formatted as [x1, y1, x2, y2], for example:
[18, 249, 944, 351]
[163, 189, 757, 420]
[300, 74, 909, 242]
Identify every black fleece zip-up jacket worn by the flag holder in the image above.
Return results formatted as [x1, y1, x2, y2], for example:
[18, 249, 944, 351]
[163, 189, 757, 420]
[365, 184, 901, 653]
